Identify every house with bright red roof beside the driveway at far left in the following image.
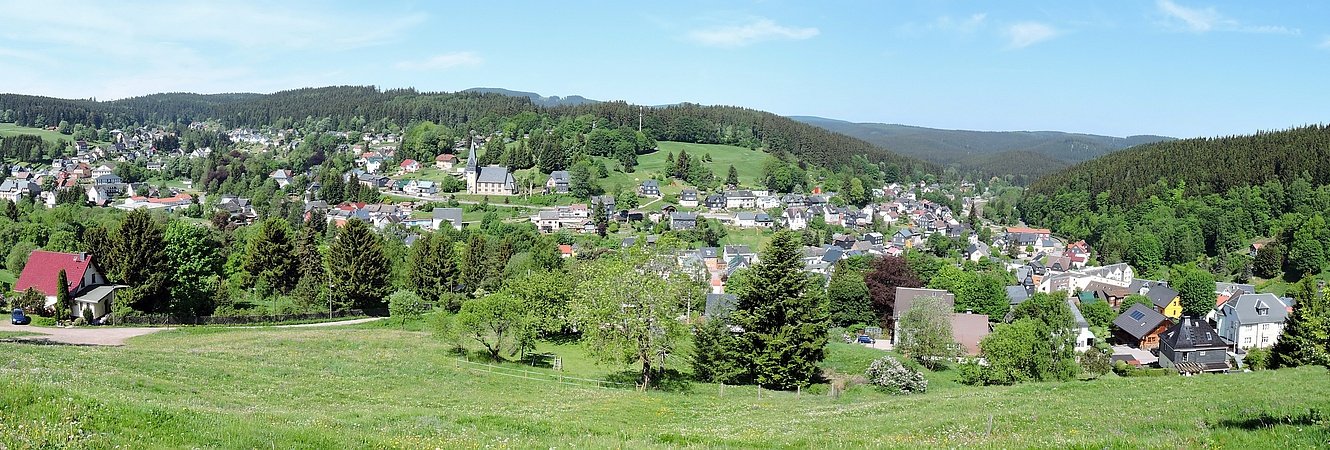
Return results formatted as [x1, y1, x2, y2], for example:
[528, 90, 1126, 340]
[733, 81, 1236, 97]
[13, 250, 125, 320]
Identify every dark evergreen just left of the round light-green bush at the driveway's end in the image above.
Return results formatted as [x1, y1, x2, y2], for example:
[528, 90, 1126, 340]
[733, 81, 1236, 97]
[327, 218, 392, 309]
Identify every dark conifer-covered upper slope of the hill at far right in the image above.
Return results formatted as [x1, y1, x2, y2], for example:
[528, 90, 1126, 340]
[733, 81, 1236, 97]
[1027, 125, 1330, 206]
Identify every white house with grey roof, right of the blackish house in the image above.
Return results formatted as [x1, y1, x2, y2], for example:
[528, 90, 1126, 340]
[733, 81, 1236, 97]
[1214, 293, 1289, 349]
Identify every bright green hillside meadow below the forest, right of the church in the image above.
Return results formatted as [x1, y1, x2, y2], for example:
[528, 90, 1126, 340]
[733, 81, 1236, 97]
[600, 141, 769, 194]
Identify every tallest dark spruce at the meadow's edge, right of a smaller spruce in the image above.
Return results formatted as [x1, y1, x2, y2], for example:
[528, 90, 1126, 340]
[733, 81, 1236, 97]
[734, 230, 829, 389]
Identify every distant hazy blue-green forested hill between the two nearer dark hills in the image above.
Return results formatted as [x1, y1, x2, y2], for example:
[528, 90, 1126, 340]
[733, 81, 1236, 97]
[790, 116, 1172, 180]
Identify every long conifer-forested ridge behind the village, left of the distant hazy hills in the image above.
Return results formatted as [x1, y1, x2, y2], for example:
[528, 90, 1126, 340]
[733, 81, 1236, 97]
[0, 87, 940, 173]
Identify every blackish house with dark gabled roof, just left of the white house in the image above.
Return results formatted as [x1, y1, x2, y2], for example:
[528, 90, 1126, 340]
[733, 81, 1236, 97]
[1158, 316, 1229, 374]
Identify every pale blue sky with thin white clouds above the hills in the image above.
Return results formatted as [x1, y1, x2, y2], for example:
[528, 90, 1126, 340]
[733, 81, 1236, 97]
[0, 0, 1330, 137]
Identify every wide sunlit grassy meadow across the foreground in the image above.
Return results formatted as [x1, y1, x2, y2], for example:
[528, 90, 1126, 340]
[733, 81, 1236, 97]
[0, 324, 1330, 449]
